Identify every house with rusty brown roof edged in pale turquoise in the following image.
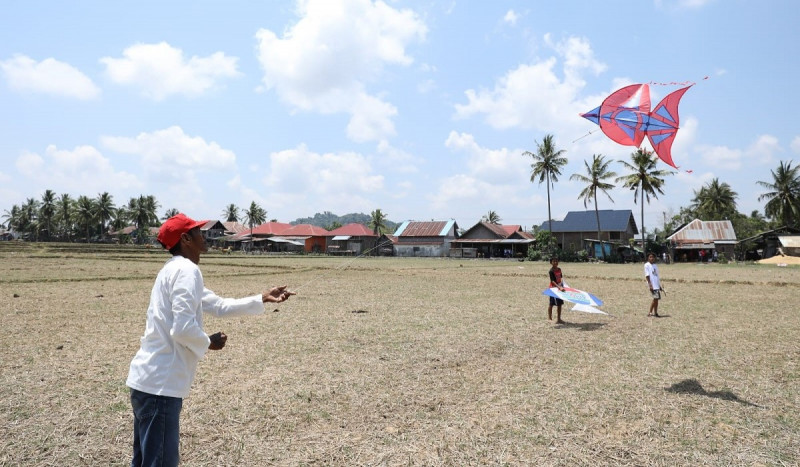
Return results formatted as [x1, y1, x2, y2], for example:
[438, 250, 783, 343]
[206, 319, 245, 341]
[394, 219, 458, 256]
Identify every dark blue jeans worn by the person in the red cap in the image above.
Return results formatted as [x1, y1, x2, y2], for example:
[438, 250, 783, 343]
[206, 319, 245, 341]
[131, 389, 183, 467]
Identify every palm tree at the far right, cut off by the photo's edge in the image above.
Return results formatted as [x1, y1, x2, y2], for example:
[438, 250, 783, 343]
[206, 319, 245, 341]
[756, 161, 800, 227]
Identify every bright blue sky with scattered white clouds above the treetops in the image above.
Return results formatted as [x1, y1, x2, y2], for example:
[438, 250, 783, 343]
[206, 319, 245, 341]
[0, 0, 800, 234]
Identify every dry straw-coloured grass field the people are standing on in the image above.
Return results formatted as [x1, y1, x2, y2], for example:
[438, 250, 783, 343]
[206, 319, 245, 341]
[0, 244, 800, 466]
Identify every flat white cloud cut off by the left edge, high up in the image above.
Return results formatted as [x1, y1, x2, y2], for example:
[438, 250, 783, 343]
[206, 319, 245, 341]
[0, 55, 100, 100]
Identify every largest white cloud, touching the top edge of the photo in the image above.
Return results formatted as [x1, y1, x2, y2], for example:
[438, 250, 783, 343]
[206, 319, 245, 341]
[256, 0, 427, 142]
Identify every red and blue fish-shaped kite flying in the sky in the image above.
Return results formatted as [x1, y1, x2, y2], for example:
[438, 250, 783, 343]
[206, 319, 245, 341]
[581, 84, 692, 169]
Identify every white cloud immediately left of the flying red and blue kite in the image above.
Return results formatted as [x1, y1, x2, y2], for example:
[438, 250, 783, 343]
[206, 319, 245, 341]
[455, 36, 605, 132]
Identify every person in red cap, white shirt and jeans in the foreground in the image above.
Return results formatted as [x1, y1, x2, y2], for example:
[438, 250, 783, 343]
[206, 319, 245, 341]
[126, 214, 294, 466]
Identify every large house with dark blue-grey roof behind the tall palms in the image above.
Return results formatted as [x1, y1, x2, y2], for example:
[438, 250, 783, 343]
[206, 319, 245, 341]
[540, 209, 639, 251]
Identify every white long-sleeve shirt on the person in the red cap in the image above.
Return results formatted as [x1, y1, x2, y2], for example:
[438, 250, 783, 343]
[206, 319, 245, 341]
[126, 256, 264, 398]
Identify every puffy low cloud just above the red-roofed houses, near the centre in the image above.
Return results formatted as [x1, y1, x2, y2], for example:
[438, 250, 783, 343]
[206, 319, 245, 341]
[264, 145, 384, 214]
